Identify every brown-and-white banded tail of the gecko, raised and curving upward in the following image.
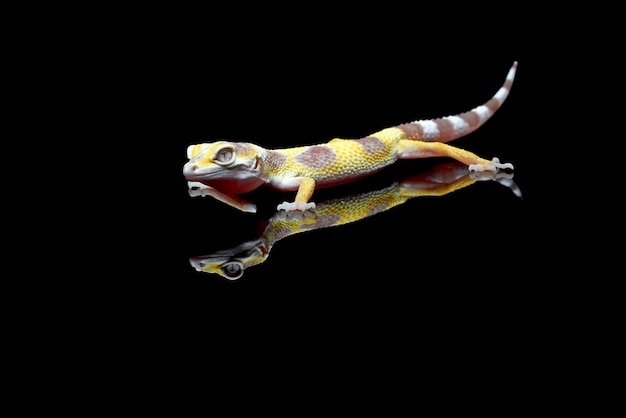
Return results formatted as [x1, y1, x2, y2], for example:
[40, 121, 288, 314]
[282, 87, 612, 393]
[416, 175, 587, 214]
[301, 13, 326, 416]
[397, 61, 517, 142]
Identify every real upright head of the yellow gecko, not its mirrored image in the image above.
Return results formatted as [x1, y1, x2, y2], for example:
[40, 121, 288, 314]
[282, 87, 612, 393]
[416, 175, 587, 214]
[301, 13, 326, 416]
[183, 141, 263, 194]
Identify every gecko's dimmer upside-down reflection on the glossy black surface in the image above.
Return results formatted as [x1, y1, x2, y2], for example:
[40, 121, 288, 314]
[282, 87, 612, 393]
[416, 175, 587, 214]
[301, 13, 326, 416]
[189, 161, 521, 280]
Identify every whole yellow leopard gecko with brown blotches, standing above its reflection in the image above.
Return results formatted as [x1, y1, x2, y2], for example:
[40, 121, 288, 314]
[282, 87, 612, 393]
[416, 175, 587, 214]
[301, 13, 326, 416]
[183, 62, 517, 211]
